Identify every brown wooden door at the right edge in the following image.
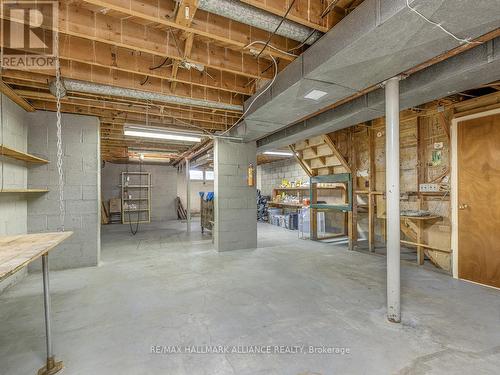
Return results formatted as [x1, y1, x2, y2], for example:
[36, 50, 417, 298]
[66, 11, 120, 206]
[457, 114, 500, 288]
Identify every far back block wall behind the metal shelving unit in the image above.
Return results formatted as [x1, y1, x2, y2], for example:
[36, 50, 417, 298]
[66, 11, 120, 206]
[101, 163, 177, 221]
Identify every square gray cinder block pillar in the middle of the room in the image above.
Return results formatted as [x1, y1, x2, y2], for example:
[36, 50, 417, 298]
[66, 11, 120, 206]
[214, 139, 257, 251]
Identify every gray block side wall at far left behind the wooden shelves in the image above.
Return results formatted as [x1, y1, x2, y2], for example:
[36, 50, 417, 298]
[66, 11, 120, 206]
[0, 94, 30, 293]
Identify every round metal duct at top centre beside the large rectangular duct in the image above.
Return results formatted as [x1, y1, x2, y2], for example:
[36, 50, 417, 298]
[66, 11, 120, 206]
[198, 0, 323, 44]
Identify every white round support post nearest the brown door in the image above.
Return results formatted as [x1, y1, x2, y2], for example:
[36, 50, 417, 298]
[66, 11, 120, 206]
[385, 77, 401, 323]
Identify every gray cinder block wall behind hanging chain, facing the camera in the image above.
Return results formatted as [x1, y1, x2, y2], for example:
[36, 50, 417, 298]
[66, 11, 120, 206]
[26, 111, 101, 270]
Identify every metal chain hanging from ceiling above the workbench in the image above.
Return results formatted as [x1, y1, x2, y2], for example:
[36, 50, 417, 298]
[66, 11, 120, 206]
[54, 24, 66, 232]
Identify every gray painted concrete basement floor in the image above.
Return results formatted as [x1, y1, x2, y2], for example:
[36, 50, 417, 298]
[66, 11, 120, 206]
[0, 222, 500, 375]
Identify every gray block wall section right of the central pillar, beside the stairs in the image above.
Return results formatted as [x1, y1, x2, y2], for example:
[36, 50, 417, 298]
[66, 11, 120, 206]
[257, 158, 309, 195]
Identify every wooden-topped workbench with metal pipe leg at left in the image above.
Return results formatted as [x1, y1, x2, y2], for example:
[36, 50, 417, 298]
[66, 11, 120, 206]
[0, 232, 73, 375]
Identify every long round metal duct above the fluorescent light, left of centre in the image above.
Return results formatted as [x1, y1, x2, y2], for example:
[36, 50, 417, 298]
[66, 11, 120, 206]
[49, 78, 243, 111]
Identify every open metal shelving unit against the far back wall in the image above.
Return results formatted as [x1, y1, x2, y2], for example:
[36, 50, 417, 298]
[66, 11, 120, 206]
[121, 172, 151, 224]
